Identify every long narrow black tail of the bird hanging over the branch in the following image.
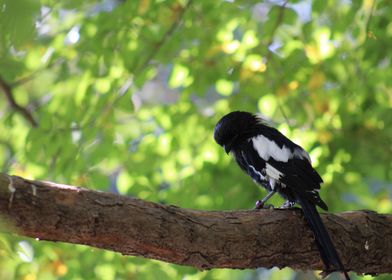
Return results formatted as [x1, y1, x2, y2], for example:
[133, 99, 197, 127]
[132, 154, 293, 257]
[298, 198, 350, 280]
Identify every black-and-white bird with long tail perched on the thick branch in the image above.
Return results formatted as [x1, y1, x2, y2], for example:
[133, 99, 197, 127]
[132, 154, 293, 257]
[214, 111, 350, 280]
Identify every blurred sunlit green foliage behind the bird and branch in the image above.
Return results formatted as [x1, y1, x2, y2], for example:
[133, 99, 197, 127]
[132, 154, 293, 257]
[0, 0, 392, 280]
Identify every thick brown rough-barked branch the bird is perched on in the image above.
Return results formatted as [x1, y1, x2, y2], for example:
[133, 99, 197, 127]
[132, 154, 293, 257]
[0, 174, 392, 274]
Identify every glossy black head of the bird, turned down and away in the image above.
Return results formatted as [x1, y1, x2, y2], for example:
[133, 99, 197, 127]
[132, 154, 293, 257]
[214, 111, 261, 154]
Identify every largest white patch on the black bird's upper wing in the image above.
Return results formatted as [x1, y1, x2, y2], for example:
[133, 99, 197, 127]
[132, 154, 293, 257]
[252, 135, 293, 162]
